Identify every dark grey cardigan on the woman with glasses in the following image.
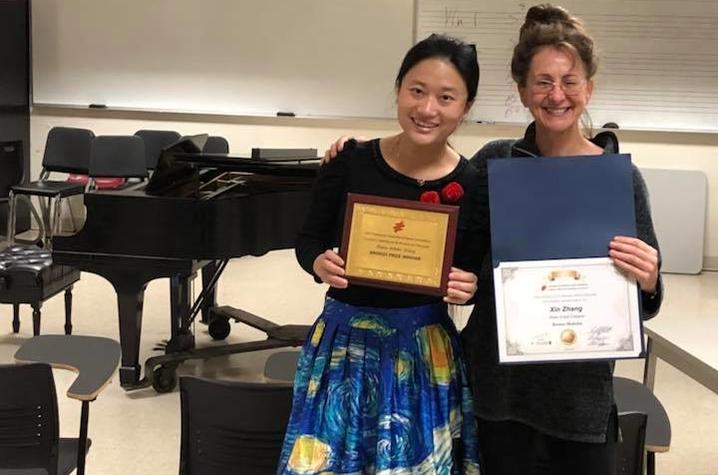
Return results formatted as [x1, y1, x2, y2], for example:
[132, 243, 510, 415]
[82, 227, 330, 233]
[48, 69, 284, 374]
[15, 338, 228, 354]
[462, 124, 663, 443]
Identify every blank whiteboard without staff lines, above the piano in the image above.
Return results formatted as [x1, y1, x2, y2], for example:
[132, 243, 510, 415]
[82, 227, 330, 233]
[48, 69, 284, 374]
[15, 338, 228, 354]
[32, 0, 414, 117]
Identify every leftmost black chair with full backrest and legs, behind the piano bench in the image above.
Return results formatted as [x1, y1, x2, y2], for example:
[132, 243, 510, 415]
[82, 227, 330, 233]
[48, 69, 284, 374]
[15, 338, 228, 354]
[8, 127, 95, 247]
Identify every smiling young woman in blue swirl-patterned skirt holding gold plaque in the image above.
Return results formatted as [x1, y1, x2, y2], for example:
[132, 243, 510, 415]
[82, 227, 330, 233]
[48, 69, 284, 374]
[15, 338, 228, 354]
[278, 35, 488, 475]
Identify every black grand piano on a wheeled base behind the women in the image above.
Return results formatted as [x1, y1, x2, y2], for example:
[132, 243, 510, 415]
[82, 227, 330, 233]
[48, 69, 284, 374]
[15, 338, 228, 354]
[52, 136, 318, 392]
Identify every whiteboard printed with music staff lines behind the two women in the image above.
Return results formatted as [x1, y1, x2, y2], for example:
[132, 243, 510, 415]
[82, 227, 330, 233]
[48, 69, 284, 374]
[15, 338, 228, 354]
[416, 0, 718, 132]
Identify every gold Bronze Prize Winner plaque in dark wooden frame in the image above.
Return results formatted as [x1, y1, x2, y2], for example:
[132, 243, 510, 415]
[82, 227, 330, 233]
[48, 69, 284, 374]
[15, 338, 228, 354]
[340, 193, 458, 295]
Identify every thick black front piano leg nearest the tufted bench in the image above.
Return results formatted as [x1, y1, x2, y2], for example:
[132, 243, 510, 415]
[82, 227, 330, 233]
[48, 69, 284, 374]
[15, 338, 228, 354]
[111, 279, 147, 386]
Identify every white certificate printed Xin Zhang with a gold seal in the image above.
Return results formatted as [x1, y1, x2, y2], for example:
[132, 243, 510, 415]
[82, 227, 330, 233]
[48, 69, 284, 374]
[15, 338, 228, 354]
[494, 258, 643, 363]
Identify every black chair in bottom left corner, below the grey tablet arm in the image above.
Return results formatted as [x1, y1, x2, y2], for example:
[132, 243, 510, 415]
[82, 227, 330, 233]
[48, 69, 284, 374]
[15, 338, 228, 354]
[0, 363, 90, 475]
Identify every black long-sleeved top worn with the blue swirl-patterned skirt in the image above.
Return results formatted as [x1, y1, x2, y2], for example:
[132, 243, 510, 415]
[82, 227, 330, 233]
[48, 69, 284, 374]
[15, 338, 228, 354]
[296, 139, 488, 308]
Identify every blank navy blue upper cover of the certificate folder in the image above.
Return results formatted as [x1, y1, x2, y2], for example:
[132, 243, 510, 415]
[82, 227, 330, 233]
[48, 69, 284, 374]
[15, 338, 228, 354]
[488, 154, 636, 267]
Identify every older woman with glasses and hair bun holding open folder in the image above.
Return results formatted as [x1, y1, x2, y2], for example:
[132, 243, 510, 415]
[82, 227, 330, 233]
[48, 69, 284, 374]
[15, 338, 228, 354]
[462, 5, 662, 475]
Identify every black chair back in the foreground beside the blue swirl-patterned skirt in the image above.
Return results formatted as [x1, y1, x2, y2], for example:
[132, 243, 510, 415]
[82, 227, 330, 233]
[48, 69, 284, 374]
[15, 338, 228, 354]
[179, 376, 292, 475]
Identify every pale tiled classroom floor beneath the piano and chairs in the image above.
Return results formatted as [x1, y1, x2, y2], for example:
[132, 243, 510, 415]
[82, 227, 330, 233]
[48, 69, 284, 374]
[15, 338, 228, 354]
[0, 251, 718, 475]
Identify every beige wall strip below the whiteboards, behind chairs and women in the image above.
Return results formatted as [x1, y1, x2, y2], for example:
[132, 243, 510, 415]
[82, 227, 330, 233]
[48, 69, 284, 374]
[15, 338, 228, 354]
[30, 107, 718, 268]
